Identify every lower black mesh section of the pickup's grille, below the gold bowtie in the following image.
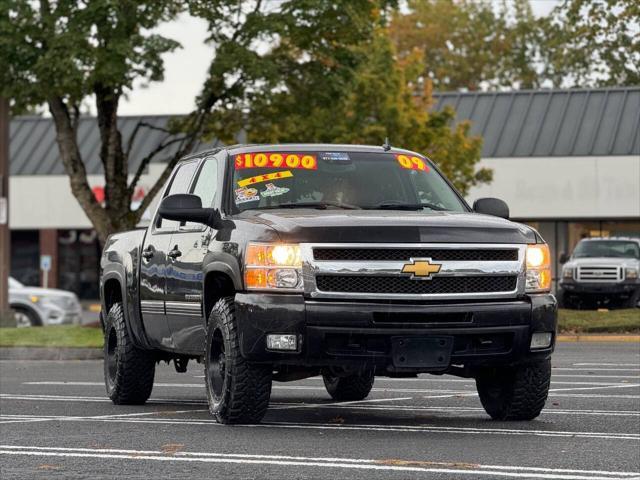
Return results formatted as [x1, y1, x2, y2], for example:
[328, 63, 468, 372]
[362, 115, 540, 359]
[316, 275, 517, 295]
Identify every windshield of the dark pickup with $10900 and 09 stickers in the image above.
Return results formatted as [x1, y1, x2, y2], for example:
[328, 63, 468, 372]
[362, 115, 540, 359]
[233, 150, 467, 212]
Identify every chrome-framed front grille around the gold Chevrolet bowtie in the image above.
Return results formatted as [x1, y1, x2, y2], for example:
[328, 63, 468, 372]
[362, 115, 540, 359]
[301, 243, 526, 300]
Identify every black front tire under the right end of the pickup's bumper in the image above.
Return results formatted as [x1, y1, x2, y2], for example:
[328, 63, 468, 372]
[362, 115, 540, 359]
[476, 359, 551, 420]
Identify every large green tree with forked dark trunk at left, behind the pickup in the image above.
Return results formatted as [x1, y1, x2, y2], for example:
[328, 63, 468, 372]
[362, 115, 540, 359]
[0, 0, 379, 242]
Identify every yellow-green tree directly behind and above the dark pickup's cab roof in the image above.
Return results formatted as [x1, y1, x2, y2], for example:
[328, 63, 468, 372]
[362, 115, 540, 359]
[247, 27, 491, 194]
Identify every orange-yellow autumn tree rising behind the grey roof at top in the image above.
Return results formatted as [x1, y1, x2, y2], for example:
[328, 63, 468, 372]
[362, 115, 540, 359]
[390, 0, 540, 91]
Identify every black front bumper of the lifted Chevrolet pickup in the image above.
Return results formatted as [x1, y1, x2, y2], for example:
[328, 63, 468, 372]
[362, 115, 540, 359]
[235, 293, 557, 372]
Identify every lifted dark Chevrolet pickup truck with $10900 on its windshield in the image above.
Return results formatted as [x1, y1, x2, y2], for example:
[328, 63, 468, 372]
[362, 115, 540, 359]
[100, 144, 557, 423]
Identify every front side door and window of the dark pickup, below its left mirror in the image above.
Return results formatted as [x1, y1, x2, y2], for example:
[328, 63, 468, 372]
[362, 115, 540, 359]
[166, 157, 222, 355]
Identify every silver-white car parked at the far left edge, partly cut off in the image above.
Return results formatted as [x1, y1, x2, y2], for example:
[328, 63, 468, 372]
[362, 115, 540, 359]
[9, 278, 82, 327]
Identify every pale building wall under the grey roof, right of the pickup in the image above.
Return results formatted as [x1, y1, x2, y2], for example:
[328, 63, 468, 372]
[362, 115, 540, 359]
[468, 156, 640, 219]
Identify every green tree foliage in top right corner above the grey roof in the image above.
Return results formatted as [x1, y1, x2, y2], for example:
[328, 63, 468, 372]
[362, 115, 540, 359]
[542, 0, 640, 87]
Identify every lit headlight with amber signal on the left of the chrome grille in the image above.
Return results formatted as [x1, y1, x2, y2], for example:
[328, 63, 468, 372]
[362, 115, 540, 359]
[244, 243, 302, 291]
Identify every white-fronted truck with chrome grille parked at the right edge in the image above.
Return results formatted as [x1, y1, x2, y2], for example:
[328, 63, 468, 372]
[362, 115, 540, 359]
[559, 237, 640, 308]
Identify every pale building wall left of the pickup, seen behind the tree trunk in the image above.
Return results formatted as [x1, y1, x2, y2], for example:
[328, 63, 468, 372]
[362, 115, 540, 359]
[9, 164, 164, 230]
